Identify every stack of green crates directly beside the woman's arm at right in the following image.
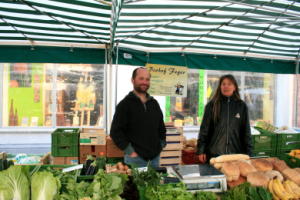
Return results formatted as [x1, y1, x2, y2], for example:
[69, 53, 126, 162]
[251, 128, 277, 157]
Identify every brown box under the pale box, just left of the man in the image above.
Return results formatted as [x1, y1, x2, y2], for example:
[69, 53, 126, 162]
[79, 145, 106, 163]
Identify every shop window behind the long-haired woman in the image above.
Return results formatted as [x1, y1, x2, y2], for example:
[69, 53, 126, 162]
[166, 70, 276, 126]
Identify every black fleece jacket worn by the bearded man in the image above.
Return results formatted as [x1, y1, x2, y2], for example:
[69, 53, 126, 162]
[110, 92, 166, 160]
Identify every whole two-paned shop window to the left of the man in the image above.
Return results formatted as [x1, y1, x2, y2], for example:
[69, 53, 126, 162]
[2, 63, 104, 127]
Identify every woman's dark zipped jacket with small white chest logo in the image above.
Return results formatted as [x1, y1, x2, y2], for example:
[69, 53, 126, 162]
[197, 96, 252, 157]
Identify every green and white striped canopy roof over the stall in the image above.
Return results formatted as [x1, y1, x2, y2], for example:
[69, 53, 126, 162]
[0, 0, 300, 72]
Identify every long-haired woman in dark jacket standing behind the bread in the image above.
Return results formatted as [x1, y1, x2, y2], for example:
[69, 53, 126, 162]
[197, 74, 252, 163]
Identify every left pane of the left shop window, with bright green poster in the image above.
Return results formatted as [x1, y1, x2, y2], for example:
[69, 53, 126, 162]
[3, 63, 45, 127]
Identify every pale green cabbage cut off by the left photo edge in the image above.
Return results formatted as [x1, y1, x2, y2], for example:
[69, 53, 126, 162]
[0, 166, 30, 200]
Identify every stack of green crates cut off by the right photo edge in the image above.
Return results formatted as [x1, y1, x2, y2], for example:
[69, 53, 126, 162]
[277, 133, 300, 157]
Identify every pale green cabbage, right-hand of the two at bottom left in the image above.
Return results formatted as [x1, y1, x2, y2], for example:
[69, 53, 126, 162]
[31, 171, 60, 200]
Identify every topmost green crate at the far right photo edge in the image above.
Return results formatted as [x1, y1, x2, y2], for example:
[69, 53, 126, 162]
[277, 133, 300, 150]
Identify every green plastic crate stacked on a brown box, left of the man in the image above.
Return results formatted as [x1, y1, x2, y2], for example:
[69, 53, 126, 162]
[51, 128, 80, 165]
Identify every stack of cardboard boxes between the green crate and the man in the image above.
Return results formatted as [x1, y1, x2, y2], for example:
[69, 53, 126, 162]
[79, 128, 106, 163]
